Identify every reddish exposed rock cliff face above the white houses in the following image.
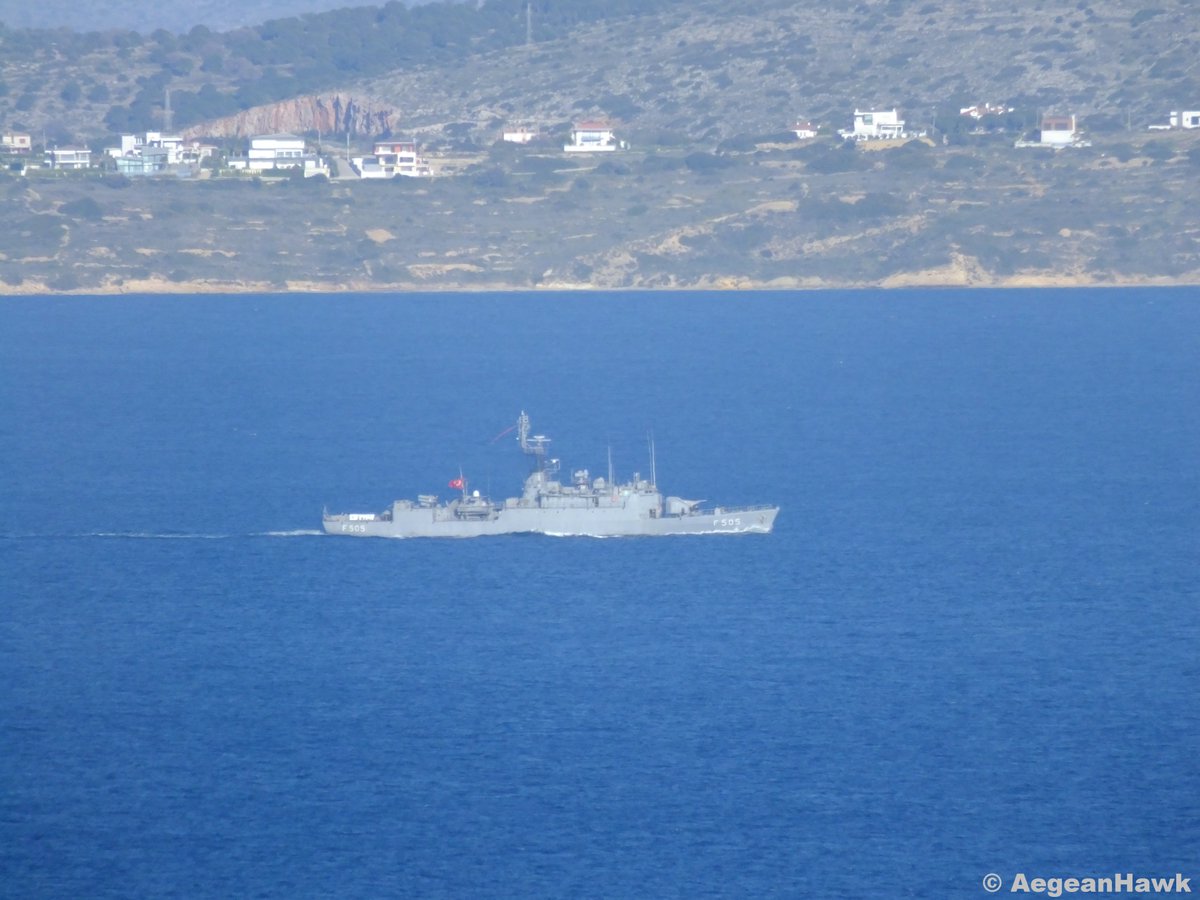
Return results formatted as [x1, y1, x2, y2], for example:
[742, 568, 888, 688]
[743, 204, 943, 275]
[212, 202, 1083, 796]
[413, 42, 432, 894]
[184, 94, 400, 138]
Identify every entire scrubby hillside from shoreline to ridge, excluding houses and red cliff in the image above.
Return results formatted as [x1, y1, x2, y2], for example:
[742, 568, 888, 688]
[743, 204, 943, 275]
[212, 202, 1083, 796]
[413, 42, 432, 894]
[0, 0, 1200, 292]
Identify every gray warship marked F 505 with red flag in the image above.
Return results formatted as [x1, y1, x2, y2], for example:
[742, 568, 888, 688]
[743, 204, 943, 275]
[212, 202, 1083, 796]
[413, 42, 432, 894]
[324, 412, 779, 538]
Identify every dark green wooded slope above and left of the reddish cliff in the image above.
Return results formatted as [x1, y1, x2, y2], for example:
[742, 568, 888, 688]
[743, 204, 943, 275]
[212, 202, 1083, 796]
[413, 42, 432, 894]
[0, 0, 679, 140]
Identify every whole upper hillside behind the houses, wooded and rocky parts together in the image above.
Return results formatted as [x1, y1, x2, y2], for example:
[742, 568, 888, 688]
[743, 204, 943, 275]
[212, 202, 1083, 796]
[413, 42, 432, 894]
[0, 0, 1200, 144]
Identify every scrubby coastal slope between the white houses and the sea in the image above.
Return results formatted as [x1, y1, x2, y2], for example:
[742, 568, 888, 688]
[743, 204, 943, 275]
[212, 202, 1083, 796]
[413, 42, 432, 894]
[0, 127, 1200, 293]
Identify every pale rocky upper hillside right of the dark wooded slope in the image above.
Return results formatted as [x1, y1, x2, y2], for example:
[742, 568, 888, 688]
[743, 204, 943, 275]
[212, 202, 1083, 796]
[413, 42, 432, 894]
[350, 0, 1200, 146]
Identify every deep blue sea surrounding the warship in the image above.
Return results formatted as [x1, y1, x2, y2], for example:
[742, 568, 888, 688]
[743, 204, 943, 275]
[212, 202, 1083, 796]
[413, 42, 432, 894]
[0, 288, 1200, 898]
